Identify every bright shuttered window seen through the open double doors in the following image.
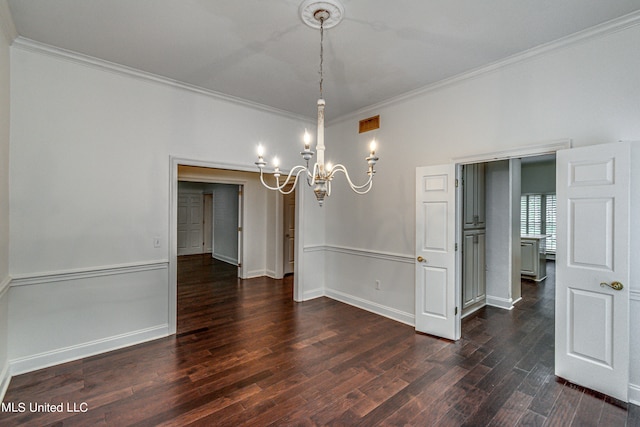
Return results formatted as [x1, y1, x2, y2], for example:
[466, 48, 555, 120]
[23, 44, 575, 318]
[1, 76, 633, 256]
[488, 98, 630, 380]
[520, 194, 556, 254]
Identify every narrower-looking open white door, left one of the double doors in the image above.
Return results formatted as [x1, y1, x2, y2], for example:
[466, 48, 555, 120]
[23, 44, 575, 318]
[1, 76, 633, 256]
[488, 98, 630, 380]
[415, 164, 460, 340]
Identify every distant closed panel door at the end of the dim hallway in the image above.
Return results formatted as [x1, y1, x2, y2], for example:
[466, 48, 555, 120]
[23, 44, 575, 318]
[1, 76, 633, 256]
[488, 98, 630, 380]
[178, 193, 204, 255]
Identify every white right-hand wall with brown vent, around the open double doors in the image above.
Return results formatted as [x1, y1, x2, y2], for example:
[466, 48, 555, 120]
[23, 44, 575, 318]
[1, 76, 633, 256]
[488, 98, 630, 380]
[325, 20, 640, 394]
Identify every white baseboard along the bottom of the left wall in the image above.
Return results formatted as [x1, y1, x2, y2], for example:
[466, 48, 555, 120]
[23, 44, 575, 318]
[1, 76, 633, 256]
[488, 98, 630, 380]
[9, 324, 169, 375]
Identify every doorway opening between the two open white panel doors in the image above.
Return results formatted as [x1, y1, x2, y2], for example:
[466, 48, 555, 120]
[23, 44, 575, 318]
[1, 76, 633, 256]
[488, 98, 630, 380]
[458, 154, 556, 317]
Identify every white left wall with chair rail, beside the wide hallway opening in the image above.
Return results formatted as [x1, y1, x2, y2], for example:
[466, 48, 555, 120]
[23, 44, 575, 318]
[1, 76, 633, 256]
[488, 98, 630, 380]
[8, 41, 310, 373]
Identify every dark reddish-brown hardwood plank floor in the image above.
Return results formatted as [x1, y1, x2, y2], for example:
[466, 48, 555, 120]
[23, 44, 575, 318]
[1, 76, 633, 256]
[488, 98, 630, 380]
[0, 256, 640, 426]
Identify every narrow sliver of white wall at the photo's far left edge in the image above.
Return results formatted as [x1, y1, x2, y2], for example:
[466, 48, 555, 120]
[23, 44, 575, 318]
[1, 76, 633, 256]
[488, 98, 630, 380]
[0, 0, 12, 397]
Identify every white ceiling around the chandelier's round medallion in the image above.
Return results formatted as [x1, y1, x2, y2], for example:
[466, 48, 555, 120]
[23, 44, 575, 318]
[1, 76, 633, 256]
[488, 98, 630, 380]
[9, 0, 640, 119]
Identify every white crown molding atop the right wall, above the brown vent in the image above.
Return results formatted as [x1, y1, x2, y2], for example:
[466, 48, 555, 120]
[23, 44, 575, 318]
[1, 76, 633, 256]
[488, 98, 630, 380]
[327, 10, 640, 125]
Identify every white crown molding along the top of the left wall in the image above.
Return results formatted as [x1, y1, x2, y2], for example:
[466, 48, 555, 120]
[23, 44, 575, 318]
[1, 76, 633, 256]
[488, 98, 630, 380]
[11, 36, 312, 123]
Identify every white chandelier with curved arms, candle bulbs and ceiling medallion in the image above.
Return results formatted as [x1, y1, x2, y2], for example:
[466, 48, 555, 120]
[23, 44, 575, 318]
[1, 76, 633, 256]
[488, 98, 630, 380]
[255, 0, 378, 206]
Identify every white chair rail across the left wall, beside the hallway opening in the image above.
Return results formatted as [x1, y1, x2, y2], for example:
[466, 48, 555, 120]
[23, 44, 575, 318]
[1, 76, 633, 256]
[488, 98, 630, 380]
[11, 260, 168, 287]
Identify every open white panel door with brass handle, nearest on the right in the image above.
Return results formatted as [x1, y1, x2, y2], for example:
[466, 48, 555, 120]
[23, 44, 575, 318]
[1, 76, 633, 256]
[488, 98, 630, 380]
[555, 143, 630, 402]
